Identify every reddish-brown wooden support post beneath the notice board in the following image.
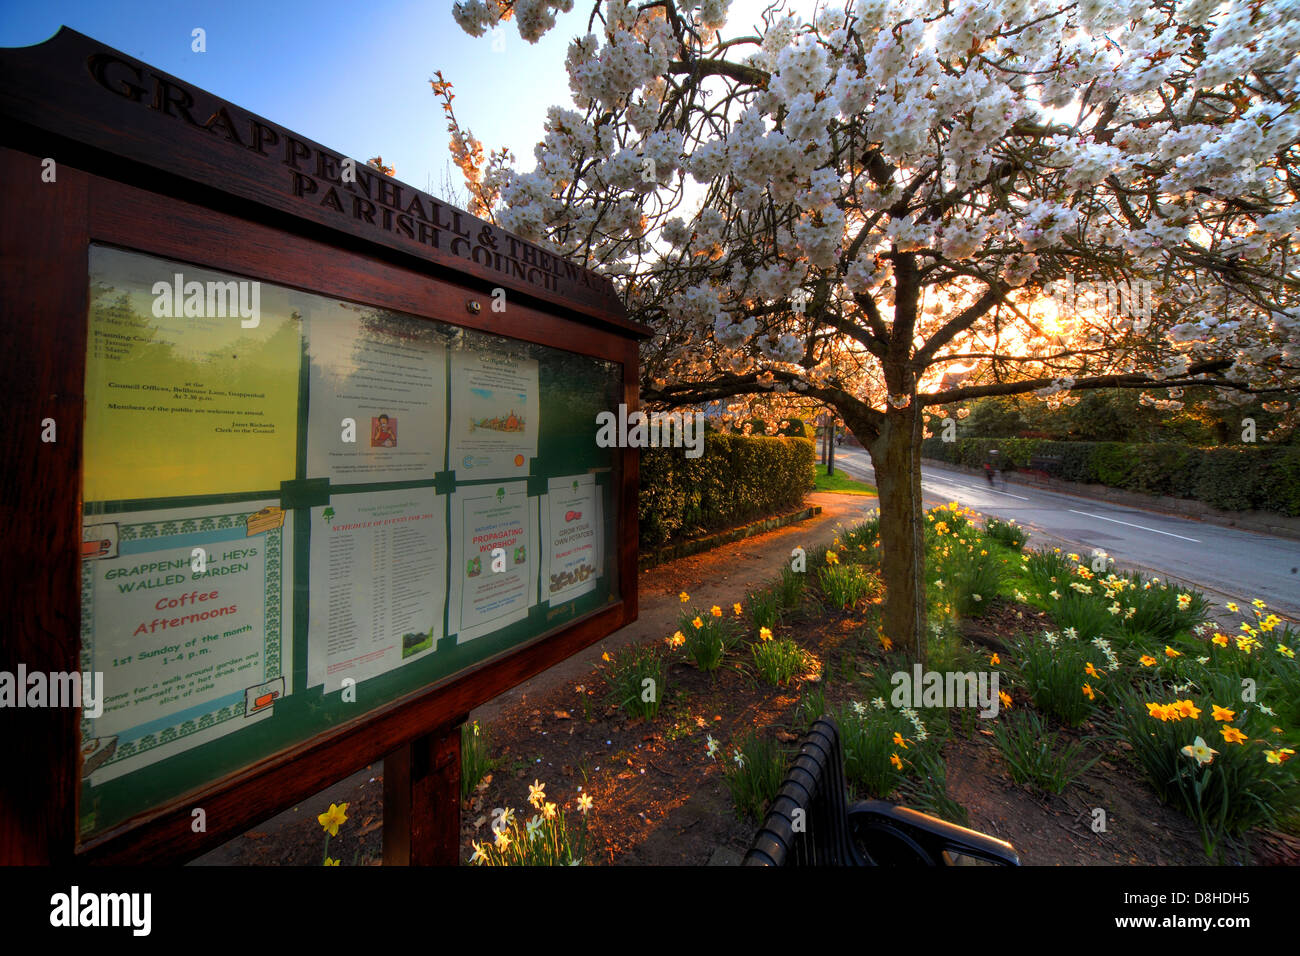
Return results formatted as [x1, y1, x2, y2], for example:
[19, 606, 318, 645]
[384, 717, 468, 866]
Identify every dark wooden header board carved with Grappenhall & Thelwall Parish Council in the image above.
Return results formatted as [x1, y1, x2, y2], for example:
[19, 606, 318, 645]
[0, 27, 650, 337]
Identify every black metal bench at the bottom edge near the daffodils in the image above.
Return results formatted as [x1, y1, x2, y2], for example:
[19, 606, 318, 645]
[744, 717, 1021, 866]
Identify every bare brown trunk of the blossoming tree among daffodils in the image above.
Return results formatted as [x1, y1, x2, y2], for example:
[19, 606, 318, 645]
[863, 399, 926, 661]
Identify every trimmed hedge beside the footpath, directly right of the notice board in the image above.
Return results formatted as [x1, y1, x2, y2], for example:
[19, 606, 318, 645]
[638, 432, 815, 548]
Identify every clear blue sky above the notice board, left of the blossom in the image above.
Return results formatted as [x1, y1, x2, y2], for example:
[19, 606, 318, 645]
[0, 0, 588, 200]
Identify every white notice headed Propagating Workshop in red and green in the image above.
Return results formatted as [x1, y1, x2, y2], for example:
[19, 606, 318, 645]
[447, 481, 537, 644]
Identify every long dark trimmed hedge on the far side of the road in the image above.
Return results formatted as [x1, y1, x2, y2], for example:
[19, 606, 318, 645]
[922, 437, 1300, 515]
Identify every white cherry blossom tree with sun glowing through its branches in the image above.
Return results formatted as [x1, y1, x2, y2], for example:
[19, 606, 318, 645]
[439, 0, 1300, 654]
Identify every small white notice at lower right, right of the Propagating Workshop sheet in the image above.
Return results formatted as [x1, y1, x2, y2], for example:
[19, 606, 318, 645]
[542, 475, 605, 605]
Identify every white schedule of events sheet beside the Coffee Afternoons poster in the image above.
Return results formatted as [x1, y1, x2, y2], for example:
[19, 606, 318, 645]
[307, 488, 447, 693]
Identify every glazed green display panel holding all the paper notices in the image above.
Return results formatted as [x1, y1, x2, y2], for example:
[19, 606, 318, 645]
[79, 245, 623, 838]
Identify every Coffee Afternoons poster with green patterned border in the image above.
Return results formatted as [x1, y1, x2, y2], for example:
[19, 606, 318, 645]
[82, 501, 294, 786]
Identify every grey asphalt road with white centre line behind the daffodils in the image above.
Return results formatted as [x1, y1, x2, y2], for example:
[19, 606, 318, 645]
[835, 447, 1300, 620]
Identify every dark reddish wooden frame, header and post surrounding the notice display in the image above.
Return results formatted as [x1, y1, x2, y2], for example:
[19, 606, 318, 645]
[0, 29, 647, 864]
